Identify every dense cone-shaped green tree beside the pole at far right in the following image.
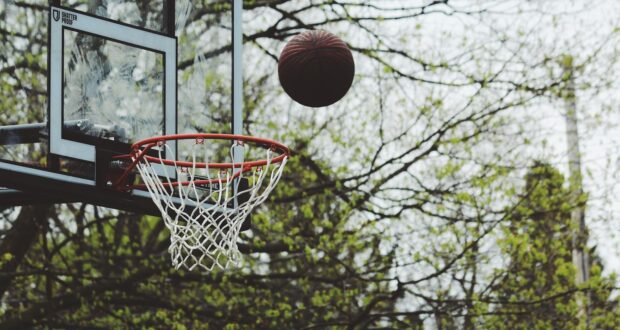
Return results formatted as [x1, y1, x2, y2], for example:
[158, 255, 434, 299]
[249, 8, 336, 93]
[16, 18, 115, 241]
[491, 162, 619, 329]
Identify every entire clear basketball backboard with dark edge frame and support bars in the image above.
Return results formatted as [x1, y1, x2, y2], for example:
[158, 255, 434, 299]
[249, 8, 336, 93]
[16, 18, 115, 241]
[0, 0, 242, 214]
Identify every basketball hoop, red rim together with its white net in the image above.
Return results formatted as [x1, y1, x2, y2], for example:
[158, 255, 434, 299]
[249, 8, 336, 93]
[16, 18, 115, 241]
[112, 134, 290, 271]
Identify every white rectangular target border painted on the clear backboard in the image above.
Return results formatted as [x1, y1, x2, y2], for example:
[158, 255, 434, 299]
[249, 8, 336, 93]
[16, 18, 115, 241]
[48, 6, 177, 168]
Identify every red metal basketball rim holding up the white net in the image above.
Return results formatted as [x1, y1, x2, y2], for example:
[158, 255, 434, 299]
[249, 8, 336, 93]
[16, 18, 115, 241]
[113, 133, 291, 190]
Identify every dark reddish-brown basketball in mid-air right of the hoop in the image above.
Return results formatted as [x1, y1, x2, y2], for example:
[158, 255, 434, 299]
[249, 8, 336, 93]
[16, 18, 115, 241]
[278, 30, 355, 108]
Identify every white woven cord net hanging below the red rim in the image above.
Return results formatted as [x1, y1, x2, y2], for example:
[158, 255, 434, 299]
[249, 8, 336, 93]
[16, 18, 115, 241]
[134, 140, 287, 271]
